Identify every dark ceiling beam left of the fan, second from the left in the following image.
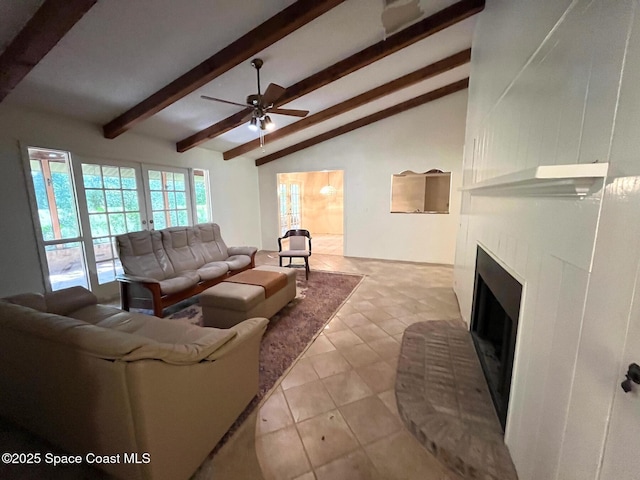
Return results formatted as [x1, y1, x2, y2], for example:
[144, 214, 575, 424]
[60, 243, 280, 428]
[102, 0, 345, 138]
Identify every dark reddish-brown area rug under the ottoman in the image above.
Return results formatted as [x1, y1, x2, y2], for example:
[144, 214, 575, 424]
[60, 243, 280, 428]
[167, 270, 363, 454]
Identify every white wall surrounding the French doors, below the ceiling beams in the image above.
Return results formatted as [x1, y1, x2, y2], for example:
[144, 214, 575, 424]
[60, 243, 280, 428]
[0, 104, 261, 296]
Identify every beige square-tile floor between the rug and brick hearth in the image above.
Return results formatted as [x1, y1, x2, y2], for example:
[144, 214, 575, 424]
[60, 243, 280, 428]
[204, 252, 460, 480]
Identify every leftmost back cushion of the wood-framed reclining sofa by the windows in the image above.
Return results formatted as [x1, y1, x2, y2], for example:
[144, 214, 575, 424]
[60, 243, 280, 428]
[116, 230, 175, 280]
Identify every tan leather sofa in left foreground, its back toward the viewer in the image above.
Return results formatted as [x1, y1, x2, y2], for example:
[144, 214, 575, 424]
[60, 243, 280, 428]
[0, 287, 267, 480]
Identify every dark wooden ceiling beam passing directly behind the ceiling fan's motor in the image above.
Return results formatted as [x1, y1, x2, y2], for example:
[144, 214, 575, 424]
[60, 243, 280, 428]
[176, 0, 484, 152]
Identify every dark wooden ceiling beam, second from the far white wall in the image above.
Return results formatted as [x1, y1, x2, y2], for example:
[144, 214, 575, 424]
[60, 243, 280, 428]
[222, 48, 471, 160]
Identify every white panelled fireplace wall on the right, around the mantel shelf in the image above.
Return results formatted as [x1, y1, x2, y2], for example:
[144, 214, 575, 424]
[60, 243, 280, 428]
[455, 0, 640, 480]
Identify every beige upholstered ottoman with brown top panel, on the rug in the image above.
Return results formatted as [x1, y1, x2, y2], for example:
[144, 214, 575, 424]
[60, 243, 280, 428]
[200, 265, 297, 328]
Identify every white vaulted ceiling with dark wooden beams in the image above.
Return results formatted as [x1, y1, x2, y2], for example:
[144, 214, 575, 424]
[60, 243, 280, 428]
[0, 0, 484, 165]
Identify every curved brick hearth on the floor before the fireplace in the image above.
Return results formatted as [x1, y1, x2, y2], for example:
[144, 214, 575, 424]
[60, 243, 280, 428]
[396, 321, 517, 480]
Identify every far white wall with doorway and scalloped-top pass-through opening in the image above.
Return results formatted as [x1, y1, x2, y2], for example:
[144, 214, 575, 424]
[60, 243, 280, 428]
[259, 91, 467, 264]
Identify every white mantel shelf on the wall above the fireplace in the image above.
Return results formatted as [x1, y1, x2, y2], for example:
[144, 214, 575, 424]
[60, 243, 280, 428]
[460, 163, 609, 197]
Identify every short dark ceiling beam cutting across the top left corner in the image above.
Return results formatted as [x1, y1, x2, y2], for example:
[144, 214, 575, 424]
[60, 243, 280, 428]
[0, 0, 97, 102]
